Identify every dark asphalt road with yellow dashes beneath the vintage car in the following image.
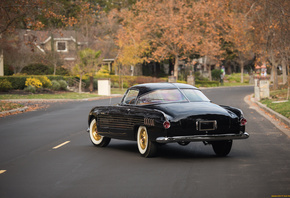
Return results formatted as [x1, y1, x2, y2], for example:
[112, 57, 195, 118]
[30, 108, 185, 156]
[0, 87, 290, 198]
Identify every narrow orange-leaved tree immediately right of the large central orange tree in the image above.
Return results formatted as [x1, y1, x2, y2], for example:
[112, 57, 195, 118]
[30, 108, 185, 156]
[192, 0, 230, 80]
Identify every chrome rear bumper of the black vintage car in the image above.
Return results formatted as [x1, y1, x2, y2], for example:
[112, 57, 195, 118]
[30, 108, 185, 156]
[156, 132, 250, 143]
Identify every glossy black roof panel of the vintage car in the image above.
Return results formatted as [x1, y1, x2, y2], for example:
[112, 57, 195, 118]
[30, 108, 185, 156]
[130, 83, 197, 95]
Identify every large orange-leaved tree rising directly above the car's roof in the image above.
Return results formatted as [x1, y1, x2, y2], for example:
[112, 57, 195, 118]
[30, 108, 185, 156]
[118, 0, 195, 78]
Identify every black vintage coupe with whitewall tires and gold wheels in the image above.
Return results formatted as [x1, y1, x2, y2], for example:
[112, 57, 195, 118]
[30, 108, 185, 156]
[88, 83, 249, 157]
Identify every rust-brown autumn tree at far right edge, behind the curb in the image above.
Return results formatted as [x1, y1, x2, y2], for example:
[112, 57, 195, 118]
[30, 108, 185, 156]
[244, 0, 290, 89]
